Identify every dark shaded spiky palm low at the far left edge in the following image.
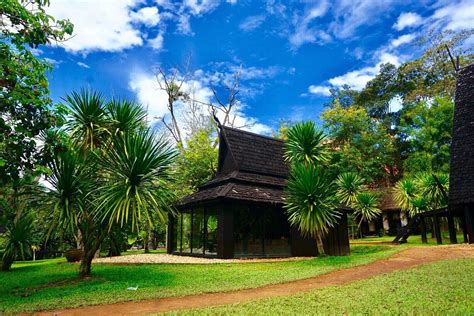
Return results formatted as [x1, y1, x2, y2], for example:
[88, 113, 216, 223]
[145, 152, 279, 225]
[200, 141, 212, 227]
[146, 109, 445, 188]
[2, 215, 33, 271]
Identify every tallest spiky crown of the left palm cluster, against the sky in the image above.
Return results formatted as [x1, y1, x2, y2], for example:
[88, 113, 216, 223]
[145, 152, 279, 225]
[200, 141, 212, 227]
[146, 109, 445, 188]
[64, 90, 107, 152]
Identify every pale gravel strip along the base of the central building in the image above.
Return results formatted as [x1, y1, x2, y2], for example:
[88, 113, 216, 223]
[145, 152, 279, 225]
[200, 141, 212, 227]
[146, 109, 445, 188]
[93, 254, 311, 264]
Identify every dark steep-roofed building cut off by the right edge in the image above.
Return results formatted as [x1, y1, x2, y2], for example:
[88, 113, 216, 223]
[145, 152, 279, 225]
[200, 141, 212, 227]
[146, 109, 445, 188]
[449, 64, 474, 243]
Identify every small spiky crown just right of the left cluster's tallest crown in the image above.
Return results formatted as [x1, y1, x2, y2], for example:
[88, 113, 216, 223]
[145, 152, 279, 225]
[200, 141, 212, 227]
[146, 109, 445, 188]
[106, 99, 147, 135]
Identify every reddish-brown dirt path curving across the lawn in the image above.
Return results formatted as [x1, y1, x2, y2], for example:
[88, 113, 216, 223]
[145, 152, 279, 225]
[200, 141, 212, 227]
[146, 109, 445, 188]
[36, 244, 474, 315]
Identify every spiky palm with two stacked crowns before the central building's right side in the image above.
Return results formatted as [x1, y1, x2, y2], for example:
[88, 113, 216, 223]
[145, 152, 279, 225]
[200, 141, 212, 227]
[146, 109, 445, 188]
[285, 122, 341, 254]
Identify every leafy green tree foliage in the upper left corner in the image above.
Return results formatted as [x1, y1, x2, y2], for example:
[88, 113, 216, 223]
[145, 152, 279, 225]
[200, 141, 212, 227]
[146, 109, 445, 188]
[0, 0, 73, 184]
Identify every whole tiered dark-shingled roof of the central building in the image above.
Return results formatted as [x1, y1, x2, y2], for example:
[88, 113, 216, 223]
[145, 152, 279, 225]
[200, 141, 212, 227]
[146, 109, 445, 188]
[178, 127, 289, 208]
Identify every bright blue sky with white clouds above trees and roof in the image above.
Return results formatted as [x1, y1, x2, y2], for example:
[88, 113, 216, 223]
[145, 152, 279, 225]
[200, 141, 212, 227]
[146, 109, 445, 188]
[36, 0, 474, 133]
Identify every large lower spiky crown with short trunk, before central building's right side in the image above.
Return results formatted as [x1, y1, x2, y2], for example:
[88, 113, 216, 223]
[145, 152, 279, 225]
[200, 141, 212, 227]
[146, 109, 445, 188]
[285, 163, 341, 254]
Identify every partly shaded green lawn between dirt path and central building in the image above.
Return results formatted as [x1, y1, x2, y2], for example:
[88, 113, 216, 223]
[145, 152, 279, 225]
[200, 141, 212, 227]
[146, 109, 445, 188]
[0, 245, 403, 314]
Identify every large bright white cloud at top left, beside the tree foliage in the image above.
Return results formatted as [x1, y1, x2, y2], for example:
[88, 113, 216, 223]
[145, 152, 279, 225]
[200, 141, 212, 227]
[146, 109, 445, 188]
[48, 0, 143, 53]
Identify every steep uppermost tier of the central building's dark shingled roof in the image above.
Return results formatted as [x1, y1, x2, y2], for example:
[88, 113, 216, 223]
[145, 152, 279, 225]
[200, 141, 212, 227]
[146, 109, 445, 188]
[221, 126, 289, 178]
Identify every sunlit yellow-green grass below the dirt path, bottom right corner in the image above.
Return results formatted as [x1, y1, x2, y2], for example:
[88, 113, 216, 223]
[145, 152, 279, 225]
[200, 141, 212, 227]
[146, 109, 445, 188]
[178, 259, 474, 315]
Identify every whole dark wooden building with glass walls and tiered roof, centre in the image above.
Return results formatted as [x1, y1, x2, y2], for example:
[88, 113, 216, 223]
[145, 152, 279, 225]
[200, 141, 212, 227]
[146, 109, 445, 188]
[167, 127, 349, 258]
